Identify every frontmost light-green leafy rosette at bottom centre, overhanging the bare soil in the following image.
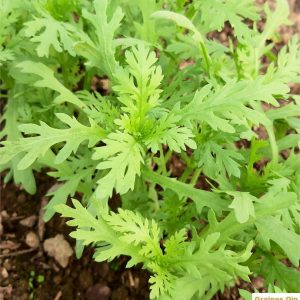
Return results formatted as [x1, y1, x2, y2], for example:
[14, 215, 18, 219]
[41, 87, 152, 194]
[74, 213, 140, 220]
[56, 200, 252, 299]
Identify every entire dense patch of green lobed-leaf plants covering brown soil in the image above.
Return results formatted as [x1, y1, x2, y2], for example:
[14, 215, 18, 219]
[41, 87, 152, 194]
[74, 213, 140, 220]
[0, 0, 300, 300]
